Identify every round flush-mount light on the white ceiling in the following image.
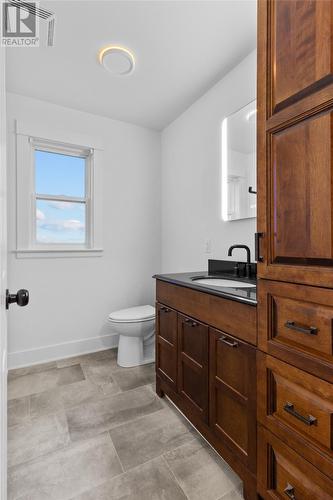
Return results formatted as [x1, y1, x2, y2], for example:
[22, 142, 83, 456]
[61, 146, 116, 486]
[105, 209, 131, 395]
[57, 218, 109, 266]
[98, 45, 135, 76]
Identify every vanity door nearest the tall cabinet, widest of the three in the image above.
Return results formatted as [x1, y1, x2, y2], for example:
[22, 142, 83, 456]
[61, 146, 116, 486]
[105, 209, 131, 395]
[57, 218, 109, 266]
[209, 329, 256, 472]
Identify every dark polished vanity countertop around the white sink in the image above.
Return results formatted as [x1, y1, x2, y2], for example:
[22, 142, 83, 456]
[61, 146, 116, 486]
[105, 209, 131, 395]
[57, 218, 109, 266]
[153, 271, 257, 306]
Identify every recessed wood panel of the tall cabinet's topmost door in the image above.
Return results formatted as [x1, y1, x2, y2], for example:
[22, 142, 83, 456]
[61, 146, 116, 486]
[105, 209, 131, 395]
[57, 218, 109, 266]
[270, 0, 333, 111]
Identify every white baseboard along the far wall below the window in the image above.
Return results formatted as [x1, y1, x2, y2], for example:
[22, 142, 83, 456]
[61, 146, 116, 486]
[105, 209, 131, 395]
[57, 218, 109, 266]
[7, 335, 119, 370]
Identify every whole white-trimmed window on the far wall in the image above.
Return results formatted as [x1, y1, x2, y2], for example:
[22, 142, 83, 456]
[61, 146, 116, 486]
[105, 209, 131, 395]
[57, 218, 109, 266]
[16, 125, 102, 257]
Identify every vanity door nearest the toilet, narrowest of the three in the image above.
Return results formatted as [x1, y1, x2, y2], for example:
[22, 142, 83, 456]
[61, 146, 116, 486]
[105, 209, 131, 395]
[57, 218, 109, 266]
[156, 304, 178, 391]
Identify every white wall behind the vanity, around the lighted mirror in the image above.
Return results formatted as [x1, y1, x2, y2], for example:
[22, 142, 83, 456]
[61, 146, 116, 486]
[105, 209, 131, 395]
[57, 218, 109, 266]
[161, 52, 256, 272]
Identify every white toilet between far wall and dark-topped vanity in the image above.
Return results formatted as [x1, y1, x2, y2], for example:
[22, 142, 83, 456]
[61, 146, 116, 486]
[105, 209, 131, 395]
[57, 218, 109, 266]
[109, 305, 155, 368]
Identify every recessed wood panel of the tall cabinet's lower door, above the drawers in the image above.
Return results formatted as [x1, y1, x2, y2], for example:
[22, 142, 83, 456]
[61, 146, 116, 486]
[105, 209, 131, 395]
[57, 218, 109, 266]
[271, 113, 333, 265]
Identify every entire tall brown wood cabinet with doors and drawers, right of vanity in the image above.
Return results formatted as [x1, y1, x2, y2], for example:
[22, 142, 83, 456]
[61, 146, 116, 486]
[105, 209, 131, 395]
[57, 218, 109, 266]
[257, 0, 333, 500]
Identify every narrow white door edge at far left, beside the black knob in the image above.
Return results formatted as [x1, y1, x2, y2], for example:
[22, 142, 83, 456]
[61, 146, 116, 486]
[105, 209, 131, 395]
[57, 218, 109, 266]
[0, 42, 7, 500]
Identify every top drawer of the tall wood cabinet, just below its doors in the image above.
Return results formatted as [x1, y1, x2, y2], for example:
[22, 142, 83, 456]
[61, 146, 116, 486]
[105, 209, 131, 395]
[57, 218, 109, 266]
[258, 280, 333, 382]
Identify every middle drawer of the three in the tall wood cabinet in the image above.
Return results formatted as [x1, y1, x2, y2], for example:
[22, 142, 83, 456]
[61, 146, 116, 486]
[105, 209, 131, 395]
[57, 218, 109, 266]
[257, 352, 333, 473]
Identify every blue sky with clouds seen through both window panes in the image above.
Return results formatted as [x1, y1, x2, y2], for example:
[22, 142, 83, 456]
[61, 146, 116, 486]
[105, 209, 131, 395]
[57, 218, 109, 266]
[35, 150, 86, 244]
